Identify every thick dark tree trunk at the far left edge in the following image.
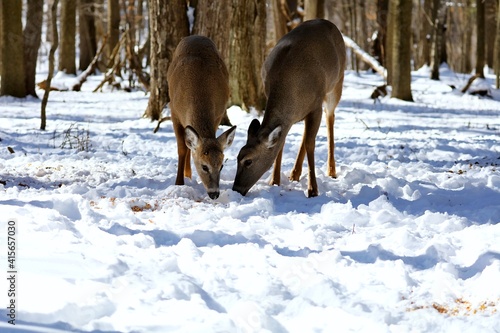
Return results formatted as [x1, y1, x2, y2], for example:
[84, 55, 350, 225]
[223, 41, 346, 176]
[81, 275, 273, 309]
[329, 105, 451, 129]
[0, 0, 26, 97]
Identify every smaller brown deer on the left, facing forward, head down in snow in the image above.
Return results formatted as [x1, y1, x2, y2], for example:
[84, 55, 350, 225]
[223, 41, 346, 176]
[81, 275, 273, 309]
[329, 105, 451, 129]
[167, 35, 236, 199]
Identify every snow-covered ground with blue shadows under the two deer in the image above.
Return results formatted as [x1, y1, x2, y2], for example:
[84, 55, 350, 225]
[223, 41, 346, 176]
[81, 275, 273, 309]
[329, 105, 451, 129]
[0, 68, 500, 333]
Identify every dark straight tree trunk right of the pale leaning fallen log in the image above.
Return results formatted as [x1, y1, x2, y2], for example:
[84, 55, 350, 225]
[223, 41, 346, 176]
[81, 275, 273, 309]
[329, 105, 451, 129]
[389, 0, 413, 101]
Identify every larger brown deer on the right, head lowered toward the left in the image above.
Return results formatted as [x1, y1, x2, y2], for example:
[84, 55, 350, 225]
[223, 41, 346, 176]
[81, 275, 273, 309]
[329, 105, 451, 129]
[233, 19, 346, 198]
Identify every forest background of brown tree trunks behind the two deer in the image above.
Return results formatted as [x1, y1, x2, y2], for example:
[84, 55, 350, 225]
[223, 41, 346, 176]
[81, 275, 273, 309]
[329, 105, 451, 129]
[0, 0, 500, 124]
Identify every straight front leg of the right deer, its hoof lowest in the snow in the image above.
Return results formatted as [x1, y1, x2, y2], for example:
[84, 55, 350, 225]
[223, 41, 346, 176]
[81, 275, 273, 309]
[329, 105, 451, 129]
[303, 107, 322, 198]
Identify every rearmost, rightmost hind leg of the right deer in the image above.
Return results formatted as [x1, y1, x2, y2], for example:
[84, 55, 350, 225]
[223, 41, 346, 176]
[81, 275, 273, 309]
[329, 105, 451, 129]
[326, 80, 343, 178]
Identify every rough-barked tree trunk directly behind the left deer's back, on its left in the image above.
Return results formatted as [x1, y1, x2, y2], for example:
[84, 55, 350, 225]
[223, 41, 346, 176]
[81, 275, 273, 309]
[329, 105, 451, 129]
[144, 0, 189, 120]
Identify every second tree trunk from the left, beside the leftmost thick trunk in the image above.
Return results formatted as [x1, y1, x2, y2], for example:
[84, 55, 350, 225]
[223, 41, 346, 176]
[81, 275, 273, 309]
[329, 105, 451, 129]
[24, 0, 43, 97]
